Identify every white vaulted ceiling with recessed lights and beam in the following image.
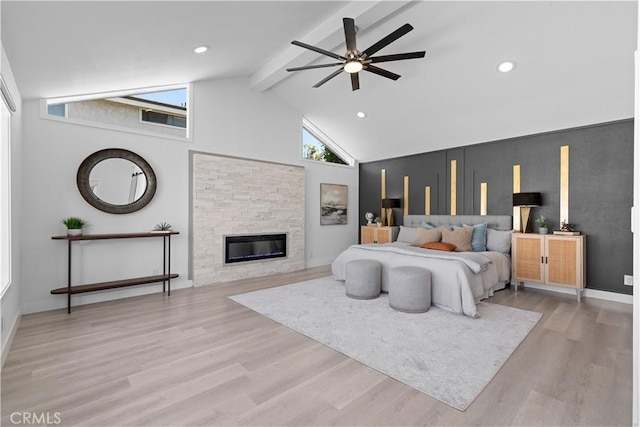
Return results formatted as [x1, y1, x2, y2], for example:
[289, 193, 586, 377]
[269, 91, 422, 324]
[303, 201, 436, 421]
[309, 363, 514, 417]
[1, 0, 638, 161]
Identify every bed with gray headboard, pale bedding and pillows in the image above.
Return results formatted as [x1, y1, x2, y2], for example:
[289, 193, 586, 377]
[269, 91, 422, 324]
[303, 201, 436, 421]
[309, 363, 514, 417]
[331, 215, 512, 317]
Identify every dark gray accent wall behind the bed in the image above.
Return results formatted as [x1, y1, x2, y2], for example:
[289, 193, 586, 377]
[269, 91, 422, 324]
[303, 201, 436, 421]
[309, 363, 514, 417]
[359, 119, 633, 294]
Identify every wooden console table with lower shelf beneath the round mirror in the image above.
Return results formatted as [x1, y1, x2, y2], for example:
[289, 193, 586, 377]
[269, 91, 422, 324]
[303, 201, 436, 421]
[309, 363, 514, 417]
[51, 231, 180, 313]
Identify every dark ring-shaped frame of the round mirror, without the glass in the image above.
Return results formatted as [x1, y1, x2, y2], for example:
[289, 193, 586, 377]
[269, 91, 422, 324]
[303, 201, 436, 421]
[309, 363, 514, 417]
[76, 148, 158, 214]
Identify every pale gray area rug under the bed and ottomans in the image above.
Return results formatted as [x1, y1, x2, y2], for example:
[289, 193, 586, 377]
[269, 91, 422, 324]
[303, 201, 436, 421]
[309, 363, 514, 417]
[229, 277, 542, 411]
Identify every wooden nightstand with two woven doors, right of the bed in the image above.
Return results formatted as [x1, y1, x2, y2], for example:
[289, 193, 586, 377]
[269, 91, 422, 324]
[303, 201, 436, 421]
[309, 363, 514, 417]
[511, 233, 587, 302]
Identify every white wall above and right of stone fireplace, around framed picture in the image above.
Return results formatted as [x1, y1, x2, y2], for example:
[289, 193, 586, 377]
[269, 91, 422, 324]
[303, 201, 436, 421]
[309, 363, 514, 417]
[193, 79, 359, 267]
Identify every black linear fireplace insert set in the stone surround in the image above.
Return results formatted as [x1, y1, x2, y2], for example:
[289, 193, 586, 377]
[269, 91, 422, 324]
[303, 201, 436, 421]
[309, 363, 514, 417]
[224, 233, 287, 264]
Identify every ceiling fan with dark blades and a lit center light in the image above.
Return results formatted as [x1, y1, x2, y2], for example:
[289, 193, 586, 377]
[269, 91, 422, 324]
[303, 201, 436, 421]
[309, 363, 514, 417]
[287, 18, 425, 90]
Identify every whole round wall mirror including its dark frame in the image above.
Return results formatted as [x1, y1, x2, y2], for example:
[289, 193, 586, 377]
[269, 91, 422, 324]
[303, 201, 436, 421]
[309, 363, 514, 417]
[76, 148, 156, 214]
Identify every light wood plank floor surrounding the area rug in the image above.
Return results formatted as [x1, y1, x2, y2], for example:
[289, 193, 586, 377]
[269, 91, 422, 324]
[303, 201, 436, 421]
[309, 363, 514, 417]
[1, 267, 632, 426]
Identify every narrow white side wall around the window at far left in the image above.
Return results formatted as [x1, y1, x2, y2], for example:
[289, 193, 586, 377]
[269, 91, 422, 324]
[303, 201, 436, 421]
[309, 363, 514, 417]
[0, 43, 24, 362]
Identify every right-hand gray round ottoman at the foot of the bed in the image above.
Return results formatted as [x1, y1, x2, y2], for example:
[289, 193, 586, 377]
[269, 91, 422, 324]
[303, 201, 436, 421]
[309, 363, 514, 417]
[389, 266, 431, 313]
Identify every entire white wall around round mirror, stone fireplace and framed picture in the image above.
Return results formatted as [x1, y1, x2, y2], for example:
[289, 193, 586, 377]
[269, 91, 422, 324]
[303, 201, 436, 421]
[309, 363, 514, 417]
[22, 79, 358, 313]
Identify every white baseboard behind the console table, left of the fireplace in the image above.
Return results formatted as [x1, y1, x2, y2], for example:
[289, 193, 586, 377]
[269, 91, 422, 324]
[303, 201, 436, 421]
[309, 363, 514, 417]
[22, 279, 193, 314]
